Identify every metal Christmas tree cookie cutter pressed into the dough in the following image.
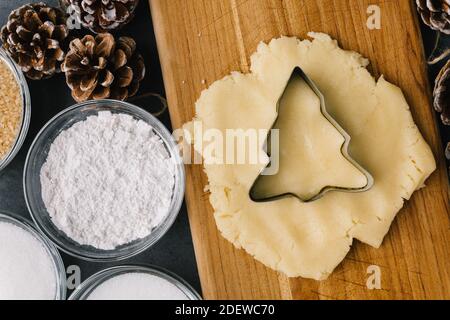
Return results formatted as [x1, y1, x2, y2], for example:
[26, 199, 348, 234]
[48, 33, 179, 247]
[249, 67, 374, 203]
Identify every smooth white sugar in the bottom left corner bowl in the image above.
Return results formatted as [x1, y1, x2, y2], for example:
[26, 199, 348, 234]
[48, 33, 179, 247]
[0, 222, 57, 300]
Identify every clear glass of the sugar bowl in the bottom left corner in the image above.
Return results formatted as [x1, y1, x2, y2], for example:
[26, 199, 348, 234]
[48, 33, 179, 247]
[0, 212, 67, 300]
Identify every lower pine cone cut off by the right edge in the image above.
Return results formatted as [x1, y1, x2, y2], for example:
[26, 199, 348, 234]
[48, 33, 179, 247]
[434, 61, 450, 126]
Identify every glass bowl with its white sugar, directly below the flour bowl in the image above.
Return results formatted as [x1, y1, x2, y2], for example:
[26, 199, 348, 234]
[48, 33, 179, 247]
[69, 266, 200, 300]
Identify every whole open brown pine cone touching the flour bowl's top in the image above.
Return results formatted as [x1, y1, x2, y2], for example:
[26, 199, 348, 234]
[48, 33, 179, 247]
[62, 33, 145, 102]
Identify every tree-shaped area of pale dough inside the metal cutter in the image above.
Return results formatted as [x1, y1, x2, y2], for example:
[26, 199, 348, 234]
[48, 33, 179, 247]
[253, 74, 368, 200]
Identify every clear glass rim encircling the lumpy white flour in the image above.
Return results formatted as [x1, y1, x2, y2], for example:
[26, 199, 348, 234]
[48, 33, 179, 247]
[23, 99, 186, 262]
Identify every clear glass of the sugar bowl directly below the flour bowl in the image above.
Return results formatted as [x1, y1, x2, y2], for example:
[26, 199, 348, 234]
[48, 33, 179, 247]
[69, 266, 201, 300]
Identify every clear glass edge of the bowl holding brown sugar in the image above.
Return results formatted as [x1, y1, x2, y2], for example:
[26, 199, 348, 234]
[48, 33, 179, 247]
[0, 48, 31, 172]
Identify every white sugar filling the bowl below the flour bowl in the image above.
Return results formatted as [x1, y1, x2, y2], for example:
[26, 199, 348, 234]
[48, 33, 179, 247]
[88, 272, 188, 300]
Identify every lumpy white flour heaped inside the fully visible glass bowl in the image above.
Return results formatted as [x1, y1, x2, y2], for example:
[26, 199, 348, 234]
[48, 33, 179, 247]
[41, 112, 176, 250]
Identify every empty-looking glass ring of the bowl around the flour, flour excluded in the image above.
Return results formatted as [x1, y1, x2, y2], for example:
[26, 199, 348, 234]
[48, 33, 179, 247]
[23, 100, 185, 262]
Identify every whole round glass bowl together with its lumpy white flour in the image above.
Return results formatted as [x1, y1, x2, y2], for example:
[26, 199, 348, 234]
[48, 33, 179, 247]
[24, 100, 185, 261]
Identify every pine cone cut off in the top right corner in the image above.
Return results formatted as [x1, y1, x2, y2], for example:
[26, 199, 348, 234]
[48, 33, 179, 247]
[416, 0, 450, 34]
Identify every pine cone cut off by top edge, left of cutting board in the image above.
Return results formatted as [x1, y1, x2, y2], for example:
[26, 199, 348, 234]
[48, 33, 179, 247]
[66, 0, 139, 33]
